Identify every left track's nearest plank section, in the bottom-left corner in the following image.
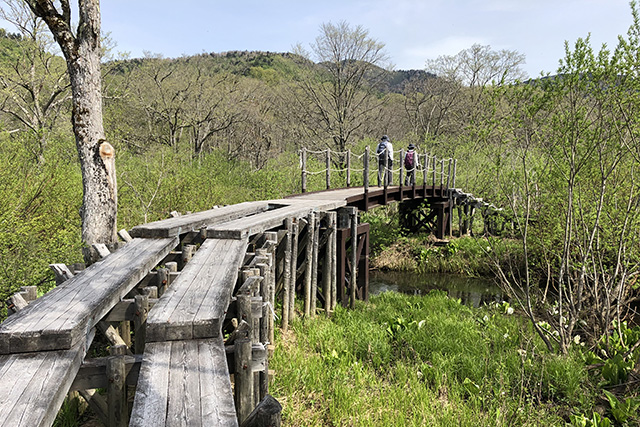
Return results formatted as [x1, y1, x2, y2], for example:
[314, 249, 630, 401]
[0, 346, 85, 427]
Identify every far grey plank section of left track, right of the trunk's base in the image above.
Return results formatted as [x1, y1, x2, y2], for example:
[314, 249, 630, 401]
[130, 201, 269, 237]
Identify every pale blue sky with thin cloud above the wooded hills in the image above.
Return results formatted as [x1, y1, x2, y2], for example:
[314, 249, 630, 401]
[3, 0, 631, 77]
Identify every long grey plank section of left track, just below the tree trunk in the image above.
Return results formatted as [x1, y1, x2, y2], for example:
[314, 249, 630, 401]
[0, 237, 178, 354]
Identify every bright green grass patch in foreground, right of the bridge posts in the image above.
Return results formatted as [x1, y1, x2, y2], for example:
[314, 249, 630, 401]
[270, 292, 594, 426]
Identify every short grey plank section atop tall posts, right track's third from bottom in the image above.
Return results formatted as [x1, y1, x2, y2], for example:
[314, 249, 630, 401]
[206, 202, 316, 239]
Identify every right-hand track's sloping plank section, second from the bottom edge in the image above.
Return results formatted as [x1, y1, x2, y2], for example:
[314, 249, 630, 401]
[146, 239, 247, 342]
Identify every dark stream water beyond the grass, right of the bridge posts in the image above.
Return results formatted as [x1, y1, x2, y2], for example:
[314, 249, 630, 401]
[369, 271, 507, 307]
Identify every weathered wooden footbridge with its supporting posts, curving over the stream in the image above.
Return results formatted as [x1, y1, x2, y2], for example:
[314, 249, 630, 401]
[0, 149, 496, 427]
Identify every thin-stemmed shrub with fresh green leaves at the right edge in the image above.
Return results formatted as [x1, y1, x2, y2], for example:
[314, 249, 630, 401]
[484, 3, 640, 352]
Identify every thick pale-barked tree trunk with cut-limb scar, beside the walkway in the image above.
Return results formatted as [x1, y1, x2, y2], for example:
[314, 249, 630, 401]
[25, 0, 117, 256]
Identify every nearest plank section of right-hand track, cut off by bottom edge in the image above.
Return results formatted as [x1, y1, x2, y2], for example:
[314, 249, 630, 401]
[129, 337, 238, 427]
